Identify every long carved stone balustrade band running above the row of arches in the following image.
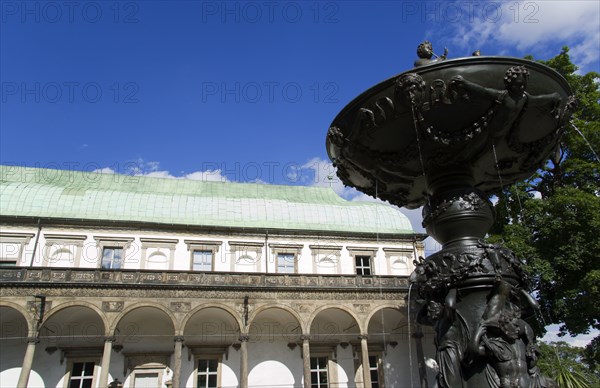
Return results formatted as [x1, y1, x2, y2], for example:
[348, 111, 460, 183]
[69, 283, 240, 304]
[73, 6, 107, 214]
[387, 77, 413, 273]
[0, 267, 408, 292]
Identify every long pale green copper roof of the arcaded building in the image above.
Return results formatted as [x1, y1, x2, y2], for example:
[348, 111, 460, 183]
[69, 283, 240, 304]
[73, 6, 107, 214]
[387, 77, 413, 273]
[0, 166, 413, 233]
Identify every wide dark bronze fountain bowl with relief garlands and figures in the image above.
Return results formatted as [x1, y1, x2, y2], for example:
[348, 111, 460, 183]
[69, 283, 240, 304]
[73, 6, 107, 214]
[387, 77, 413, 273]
[326, 57, 571, 208]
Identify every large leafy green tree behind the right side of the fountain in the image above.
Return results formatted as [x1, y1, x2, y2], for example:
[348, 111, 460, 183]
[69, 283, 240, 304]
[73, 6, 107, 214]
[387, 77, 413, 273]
[490, 47, 600, 367]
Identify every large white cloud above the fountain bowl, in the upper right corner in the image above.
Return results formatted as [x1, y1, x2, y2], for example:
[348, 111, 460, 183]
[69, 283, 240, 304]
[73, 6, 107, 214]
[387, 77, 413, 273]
[429, 0, 600, 71]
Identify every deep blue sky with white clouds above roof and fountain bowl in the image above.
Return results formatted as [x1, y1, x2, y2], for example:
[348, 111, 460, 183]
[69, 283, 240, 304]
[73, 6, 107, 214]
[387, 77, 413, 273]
[0, 0, 600, 344]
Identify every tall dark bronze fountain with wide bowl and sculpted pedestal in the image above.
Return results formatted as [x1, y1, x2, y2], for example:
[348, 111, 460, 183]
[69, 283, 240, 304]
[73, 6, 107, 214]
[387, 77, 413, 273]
[327, 57, 573, 388]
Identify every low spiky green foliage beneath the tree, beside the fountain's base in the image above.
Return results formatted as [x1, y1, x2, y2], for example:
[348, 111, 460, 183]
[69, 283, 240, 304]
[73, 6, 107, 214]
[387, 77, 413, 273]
[537, 341, 600, 388]
